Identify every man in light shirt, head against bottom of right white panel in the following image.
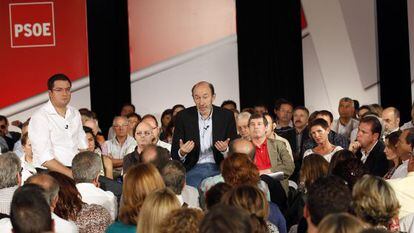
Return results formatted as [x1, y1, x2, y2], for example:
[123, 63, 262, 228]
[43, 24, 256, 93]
[331, 97, 358, 140]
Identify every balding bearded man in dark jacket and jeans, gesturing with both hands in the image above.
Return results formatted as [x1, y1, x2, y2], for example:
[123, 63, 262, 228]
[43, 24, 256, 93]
[171, 81, 237, 187]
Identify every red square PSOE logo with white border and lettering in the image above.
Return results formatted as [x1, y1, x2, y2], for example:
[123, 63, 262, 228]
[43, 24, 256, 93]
[9, 2, 56, 48]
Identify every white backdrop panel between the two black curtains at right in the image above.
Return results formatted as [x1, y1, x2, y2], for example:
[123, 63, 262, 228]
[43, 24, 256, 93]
[302, 0, 379, 117]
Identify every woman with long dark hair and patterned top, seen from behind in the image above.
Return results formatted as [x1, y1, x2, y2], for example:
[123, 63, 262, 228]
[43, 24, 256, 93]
[49, 172, 111, 233]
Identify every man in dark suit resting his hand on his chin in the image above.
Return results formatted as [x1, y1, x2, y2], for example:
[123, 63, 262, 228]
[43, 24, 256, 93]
[349, 116, 388, 177]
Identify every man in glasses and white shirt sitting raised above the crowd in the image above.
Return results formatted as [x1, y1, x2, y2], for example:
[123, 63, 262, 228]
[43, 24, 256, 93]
[29, 74, 88, 177]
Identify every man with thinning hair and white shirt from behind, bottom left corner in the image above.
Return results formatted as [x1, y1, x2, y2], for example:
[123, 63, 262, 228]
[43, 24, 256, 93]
[25, 173, 78, 233]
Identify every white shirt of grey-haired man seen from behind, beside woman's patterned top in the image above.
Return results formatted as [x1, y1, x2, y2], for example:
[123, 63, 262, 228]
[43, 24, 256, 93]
[76, 183, 118, 220]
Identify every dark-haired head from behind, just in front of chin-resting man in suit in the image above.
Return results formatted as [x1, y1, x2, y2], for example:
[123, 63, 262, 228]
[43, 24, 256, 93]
[331, 158, 367, 190]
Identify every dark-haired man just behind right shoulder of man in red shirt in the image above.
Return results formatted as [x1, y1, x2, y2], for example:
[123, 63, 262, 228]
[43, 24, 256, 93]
[273, 98, 293, 131]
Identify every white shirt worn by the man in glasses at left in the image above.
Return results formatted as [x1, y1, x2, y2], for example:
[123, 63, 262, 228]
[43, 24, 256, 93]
[29, 100, 88, 167]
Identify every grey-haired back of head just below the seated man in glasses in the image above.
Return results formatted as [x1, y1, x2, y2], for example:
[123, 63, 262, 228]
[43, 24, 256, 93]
[72, 151, 102, 183]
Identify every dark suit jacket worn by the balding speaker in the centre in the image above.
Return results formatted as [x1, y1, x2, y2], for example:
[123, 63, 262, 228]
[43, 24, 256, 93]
[171, 106, 237, 171]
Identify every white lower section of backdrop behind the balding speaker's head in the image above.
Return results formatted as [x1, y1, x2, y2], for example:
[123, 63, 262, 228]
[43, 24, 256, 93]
[131, 35, 240, 121]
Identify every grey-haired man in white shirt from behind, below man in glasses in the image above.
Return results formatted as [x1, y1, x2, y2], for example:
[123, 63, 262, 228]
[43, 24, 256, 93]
[72, 151, 117, 220]
